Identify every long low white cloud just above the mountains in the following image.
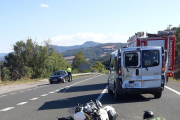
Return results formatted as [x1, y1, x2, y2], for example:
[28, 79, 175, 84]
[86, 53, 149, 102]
[51, 33, 128, 46]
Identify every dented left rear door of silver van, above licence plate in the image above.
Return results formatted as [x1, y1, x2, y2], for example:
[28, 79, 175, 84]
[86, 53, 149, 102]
[121, 48, 141, 88]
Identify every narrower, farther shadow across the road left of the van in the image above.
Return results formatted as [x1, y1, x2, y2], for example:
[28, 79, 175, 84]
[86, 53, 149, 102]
[58, 83, 107, 93]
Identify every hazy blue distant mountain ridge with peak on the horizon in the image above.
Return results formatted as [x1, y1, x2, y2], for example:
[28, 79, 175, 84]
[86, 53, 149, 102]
[51, 41, 102, 53]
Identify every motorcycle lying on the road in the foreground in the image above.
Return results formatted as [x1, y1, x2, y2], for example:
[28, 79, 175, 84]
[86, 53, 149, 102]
[58, 100, 119, 120]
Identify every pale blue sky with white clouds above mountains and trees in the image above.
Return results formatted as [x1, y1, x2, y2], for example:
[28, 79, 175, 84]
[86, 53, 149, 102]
[0, 0, 180, 53]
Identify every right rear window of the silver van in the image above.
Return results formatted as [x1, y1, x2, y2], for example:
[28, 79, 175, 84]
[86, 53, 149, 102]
[142, 50, 159, 67]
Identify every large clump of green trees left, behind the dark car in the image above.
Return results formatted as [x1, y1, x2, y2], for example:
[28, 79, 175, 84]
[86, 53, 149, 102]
[4, 39, 70, 80]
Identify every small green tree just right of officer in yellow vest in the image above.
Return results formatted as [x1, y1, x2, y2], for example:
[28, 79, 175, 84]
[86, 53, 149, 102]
[72, 51, 87, 70]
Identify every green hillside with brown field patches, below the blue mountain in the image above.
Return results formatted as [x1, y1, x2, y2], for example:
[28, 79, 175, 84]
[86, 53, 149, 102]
[62, 43, 127, 64]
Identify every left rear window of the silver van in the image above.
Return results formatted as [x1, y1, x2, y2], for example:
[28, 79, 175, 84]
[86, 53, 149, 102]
[125, 53, 138, 67]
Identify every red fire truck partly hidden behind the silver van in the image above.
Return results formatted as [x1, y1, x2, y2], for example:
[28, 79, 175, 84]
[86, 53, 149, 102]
[126, 31, 176, 84]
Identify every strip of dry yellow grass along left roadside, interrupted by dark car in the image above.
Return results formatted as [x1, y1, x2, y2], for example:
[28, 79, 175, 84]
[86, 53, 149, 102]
[0, 74, 98, 86]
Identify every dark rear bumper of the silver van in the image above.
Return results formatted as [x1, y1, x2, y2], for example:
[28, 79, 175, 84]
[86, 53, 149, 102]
[118, 87, 164, 94]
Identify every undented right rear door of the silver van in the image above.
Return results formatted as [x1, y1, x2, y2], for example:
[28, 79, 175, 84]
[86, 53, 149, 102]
[142, 47, 162, 88]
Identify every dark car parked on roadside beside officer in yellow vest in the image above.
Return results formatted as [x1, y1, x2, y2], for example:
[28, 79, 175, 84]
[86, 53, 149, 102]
[49, 70, 71, 84]
